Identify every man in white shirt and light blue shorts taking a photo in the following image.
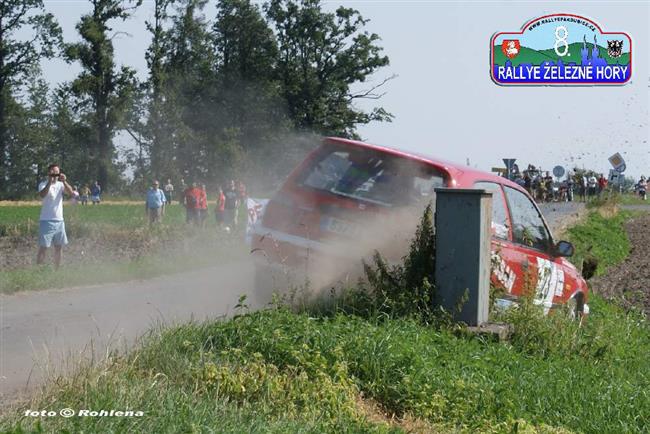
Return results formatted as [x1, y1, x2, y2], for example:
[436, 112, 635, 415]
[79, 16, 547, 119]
[36, 164, 73, 268]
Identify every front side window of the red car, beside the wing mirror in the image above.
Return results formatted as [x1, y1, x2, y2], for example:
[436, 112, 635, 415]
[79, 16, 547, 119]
[504, 187, 551, 251]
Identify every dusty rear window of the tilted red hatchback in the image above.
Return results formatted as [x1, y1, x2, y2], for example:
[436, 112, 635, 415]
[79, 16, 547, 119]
[298, 146, 444, 206]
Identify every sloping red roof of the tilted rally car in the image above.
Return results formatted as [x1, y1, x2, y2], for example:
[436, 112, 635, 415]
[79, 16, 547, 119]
[325, 137, 525, 191]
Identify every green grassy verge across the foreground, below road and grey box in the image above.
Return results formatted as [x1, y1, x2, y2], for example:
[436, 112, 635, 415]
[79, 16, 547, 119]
[0, 297, 650, 433]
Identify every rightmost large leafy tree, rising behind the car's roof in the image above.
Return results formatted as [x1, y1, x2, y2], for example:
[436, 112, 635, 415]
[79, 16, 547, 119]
[266, 0, 392, 137]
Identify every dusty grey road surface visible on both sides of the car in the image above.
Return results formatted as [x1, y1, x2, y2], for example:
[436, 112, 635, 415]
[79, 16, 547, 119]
[0, 204, 580, 402]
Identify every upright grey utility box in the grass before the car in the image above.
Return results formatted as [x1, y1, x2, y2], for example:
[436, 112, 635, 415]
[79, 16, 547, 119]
[435, 188, 492, 326]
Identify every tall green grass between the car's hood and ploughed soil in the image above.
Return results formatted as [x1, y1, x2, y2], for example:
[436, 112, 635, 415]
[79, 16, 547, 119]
[567, 210, 631, 275]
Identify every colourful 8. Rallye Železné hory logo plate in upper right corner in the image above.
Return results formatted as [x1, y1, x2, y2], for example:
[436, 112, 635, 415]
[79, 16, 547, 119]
[490, 14, 632, 85]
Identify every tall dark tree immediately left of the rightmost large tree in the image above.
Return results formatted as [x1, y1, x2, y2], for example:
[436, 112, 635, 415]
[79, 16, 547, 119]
[212, 0, 290, 181]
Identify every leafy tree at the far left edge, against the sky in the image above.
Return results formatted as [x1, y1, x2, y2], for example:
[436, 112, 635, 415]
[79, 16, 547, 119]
[0, 0, 61, 192]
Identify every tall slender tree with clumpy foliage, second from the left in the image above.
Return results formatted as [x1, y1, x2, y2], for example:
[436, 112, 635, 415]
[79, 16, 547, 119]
[66, 0, 142, 188]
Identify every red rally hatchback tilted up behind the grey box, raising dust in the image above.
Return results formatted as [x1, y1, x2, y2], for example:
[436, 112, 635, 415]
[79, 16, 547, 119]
[252, 138, 588, 314]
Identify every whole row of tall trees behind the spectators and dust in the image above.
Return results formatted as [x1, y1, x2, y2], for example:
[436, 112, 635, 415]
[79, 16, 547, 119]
[0, 0, 391, 198]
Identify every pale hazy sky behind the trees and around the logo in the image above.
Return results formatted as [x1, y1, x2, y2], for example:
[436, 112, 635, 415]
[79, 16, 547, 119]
[36, 0, 650, 177]
